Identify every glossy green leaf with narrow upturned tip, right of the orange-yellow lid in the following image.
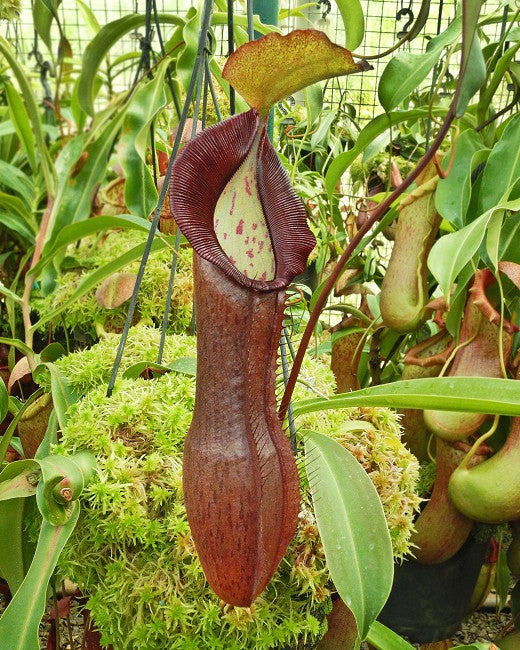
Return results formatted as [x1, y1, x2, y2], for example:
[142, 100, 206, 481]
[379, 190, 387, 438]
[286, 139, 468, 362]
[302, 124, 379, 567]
[377, 17, 462, 113]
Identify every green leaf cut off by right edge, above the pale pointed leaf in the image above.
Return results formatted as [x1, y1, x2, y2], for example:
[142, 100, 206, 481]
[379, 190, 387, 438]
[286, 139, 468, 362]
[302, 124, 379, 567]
[478, 114, 520, 213]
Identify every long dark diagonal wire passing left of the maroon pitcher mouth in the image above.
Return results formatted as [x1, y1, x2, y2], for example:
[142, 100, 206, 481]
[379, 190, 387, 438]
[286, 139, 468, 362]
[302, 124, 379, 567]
[107, 0, 213, 397]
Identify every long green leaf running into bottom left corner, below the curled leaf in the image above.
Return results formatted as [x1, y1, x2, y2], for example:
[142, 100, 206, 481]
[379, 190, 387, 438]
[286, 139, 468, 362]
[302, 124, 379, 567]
[0, 501, 79, 650]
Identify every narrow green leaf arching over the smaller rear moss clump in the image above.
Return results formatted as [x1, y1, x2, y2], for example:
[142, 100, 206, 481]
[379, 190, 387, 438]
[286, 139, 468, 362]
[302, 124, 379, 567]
[33, 214, 150, 277]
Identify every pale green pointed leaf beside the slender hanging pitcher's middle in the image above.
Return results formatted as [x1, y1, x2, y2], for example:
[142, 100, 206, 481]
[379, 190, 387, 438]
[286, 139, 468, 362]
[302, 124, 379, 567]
[428, 212, 492, 300]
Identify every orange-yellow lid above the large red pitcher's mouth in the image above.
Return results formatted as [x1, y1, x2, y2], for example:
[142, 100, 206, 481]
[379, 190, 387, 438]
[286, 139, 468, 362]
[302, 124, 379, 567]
[222, 29, 371, 113]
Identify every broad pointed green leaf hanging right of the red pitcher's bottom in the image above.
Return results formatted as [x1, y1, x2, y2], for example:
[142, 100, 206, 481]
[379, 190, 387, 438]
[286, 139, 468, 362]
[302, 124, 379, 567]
[305, 432, 394, 639]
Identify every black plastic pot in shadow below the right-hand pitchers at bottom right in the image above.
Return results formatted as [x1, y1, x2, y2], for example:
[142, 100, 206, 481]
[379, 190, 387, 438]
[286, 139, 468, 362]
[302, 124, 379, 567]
[379, 539, 488, 643]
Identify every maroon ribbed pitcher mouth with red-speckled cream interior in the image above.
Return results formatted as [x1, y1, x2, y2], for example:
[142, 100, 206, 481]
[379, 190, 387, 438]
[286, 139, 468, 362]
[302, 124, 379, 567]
[169, 109, 316, 292]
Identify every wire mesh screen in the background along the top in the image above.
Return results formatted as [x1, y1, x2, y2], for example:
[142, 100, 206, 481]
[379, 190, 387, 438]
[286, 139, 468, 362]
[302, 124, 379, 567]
[0, 0, 508, 126]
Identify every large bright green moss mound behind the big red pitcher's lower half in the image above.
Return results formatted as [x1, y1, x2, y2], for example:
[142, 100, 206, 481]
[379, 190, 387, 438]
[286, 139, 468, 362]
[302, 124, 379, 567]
[52, 327, 415, 650]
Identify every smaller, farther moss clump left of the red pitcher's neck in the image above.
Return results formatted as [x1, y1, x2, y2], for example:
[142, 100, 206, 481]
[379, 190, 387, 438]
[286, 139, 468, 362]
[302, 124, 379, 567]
[31, 230, 193, 338]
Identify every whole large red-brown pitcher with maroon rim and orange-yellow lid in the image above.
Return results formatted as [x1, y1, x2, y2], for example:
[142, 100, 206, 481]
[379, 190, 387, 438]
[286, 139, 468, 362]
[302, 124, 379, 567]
[170, 30, 366, 606]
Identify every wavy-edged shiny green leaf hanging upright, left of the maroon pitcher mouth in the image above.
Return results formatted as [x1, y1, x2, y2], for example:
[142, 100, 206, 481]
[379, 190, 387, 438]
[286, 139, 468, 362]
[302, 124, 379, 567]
[118, 61, 169, 219]
